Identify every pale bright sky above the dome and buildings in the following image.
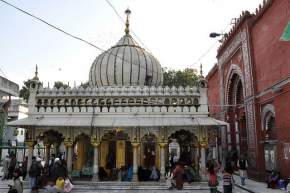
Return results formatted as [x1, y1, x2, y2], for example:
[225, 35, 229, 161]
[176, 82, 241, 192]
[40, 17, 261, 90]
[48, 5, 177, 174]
[0, 0, 262, 85]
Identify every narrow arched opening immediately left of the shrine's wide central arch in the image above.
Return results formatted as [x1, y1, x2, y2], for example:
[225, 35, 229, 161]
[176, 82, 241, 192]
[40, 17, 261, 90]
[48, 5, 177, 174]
[73, 133, 94, 176]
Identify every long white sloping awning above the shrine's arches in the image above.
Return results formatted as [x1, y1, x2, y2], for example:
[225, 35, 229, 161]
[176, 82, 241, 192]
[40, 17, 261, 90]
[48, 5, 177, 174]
[7, 116, 227, 128]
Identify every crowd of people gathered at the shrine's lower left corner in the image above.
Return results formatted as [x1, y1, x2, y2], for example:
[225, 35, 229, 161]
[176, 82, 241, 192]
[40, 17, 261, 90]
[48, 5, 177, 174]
[2, 154, 73, 193]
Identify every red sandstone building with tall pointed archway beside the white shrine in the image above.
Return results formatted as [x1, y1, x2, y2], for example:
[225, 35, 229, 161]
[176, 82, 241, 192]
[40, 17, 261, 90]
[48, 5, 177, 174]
[207, 0, 290, 179]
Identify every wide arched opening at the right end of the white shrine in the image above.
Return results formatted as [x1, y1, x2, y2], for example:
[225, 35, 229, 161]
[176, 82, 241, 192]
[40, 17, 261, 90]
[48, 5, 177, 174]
[168, 129, 198, 167]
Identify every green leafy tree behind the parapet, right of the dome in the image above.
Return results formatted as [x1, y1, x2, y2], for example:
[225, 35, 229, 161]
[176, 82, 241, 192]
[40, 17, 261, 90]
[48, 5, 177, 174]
[162, 68, 198, 87]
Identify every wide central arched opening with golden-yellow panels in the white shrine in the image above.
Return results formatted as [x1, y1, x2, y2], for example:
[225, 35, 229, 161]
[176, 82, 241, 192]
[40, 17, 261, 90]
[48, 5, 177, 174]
[101, 130, 133, 180]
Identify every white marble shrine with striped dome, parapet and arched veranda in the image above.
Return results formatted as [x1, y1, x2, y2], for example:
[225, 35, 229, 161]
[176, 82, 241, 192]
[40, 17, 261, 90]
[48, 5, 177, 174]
[8, 11, 226, 180]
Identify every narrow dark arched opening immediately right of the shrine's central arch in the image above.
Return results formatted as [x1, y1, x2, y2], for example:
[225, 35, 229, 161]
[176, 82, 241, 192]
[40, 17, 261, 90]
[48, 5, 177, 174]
[141, 133, 157, 168]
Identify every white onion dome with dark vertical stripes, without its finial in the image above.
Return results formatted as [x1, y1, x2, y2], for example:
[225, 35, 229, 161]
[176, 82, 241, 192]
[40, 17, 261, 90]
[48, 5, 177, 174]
[89, 33, 163, 87]
